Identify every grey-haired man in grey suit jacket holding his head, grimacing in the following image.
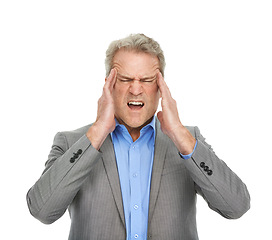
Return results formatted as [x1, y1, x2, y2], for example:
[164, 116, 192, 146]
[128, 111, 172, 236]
[27, 34, 250, 240]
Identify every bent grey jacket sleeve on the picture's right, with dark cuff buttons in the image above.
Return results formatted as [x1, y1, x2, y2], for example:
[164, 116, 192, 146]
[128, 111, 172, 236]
[184, 127, 250, 219]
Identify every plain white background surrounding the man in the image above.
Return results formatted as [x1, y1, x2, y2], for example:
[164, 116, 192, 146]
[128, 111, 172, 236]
[0, 0, 272, 240]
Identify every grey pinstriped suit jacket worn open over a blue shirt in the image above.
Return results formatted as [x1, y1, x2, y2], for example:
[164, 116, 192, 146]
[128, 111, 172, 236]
[27, 120, 250, 240]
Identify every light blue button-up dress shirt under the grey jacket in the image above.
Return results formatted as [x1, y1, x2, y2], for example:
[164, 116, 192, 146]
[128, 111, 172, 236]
[111, 117, 196, 240]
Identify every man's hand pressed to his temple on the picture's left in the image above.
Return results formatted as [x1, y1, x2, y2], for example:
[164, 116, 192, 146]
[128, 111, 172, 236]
[86, 69, 117, 150]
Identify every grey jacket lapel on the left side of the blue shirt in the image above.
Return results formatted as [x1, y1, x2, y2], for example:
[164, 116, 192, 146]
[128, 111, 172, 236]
[100, 135, 126, 226]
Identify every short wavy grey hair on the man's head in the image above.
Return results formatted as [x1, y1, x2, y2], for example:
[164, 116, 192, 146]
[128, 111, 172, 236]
[105, 34, 165, 76]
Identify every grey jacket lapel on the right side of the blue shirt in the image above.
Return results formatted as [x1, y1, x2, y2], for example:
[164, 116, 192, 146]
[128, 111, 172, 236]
[148, 120, 168, 224]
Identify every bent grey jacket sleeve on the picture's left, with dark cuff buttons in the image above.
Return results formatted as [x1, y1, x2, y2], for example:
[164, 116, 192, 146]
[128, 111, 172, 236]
[27, 133, 101, 224]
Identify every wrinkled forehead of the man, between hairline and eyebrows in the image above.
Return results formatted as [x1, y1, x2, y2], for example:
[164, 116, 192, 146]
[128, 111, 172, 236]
[112, 49, 159, 77]
